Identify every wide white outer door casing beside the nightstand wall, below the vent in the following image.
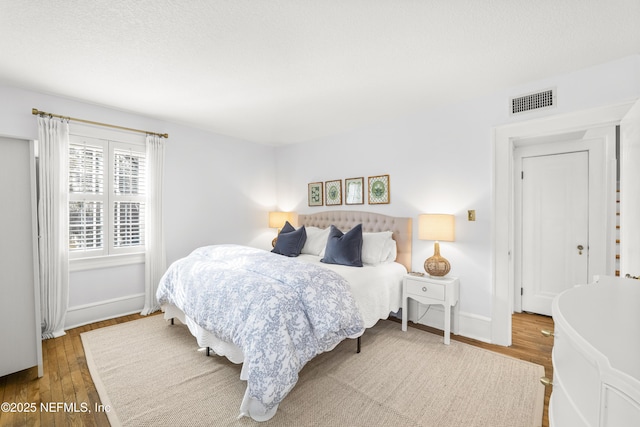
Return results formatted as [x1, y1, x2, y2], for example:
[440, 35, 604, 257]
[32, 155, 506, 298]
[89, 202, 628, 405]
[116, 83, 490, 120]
[491, 100, 635, 346]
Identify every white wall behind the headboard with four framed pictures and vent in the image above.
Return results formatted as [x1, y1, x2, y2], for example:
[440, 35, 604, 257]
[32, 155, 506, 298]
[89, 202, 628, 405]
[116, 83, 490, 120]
[276, 55, 640, 341]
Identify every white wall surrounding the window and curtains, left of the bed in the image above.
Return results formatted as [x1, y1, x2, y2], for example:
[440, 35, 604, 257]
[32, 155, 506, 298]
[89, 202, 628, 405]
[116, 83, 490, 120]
[0, 86, 276, 327]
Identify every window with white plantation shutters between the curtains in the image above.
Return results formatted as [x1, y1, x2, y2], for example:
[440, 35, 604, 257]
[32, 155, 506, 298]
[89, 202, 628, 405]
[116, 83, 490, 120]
[69, 135, 146, 259]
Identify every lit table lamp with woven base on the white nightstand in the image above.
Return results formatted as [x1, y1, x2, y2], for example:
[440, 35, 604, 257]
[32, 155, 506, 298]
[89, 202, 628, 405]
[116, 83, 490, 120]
[418, 214, 456, 277]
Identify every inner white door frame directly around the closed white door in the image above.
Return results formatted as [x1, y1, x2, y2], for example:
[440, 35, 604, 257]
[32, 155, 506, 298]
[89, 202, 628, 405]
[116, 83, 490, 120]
[513, 138, 604, 312]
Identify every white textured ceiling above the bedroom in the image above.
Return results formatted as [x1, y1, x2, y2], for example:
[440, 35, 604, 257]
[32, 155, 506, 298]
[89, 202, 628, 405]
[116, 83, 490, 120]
[0, 0, 640, 144]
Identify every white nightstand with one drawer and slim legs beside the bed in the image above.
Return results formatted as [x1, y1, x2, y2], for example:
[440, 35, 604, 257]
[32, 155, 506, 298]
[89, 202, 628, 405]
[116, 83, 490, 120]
[402, 274, 460, 344]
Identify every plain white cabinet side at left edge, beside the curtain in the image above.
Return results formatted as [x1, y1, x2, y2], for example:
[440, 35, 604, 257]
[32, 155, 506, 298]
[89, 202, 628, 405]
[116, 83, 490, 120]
[0, 137, 42, 376]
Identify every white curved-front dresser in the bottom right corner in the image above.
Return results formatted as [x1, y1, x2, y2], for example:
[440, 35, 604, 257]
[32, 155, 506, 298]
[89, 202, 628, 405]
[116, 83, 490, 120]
[549, 279, 640, 427]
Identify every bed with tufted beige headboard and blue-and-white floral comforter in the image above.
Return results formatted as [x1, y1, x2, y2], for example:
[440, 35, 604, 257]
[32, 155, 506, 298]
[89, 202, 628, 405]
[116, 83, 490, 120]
[157, 211, 412, 421]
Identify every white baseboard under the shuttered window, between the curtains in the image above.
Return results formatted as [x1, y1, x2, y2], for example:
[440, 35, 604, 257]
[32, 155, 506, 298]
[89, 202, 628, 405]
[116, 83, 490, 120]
[64, 294, 144, 330]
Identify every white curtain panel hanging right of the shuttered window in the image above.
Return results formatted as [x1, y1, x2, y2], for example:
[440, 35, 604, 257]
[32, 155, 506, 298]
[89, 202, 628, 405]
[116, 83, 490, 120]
[141, 135, 166, 316]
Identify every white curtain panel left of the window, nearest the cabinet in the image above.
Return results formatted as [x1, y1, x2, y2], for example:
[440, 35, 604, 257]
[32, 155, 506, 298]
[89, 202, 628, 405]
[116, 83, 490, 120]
[38, 117, 69, 339]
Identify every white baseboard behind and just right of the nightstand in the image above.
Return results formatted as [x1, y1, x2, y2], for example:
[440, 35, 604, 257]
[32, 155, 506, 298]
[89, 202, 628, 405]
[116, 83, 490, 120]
[409, 300, 491, 343]
